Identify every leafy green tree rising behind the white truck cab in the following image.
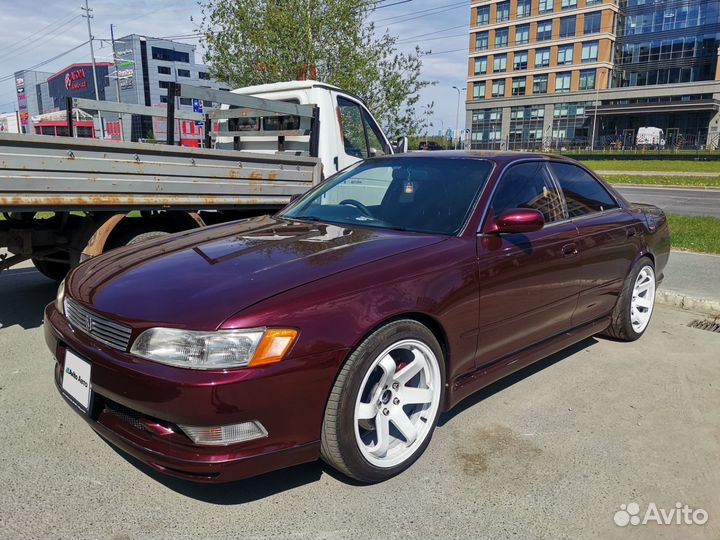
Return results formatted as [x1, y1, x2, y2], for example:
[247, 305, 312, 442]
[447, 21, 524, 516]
[199, 0, 434, 137]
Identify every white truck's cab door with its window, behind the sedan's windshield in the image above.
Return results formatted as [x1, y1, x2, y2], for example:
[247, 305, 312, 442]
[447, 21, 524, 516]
[331, 95, 391, 173]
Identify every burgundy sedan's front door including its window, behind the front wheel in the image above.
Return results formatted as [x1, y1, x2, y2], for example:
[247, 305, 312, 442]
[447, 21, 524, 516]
[477, 160, 578, 365]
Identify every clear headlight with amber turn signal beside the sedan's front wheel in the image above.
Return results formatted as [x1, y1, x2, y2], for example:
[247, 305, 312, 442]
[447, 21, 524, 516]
[130, 328, 297, 369]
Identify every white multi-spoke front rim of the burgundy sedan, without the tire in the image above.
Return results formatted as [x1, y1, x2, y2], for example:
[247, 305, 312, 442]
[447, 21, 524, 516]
[353, 339, 442, 468]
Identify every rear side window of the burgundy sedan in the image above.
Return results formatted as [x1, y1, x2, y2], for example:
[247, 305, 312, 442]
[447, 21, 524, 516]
[548, 163, 618, 218]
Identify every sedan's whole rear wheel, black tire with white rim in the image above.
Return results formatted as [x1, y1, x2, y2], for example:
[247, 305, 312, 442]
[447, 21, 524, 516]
[603, 257, 657, 341]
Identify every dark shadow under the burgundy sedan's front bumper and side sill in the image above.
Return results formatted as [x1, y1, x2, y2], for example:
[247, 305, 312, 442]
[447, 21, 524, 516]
[106, 337, 598, 505]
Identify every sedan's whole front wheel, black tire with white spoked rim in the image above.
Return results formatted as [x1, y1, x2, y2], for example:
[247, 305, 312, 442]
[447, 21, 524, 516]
[321, 319, 445, 483]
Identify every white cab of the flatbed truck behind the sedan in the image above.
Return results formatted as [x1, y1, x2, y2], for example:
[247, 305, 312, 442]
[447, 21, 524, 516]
[216, 80, 407, 177]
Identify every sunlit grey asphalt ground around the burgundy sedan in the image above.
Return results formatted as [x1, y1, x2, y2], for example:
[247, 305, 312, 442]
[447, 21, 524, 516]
[0, 260, 720, 539]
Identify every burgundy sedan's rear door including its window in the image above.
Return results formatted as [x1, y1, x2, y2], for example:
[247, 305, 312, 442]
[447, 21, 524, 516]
[548, 162, 643, 326]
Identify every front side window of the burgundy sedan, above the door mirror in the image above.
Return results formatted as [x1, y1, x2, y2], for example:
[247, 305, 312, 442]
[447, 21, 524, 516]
[490, 161, 565, 223]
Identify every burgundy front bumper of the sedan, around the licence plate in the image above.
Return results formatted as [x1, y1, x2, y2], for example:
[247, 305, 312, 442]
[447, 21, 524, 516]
[44, 304, 346, 482]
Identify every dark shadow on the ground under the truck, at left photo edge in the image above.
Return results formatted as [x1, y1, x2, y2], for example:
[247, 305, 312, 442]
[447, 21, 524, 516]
[0, 267, 58, 329]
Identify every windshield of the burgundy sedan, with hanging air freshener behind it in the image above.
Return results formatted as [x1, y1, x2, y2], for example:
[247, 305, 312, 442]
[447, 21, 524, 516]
[281, 158, 492, 235]
